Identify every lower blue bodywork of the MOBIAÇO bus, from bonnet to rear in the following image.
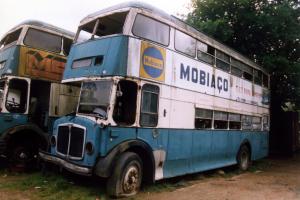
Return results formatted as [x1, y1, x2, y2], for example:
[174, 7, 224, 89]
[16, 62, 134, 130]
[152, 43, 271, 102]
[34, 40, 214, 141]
[51, 116, 268, 178]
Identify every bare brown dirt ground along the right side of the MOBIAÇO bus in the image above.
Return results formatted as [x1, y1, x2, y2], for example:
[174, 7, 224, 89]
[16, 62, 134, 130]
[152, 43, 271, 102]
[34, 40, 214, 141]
[138, 153, 300, 200]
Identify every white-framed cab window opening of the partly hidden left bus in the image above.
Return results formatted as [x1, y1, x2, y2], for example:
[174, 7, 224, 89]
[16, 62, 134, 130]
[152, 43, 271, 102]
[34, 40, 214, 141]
[5, 79, 28, 113]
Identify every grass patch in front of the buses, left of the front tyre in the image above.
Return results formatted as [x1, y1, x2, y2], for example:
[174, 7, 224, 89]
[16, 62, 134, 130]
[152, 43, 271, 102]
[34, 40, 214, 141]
[0, 170, 108, 200]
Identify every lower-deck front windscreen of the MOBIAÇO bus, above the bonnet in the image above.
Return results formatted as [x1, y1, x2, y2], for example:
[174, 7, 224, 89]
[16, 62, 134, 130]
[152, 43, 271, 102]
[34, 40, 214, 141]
[78, 80, 113, 118]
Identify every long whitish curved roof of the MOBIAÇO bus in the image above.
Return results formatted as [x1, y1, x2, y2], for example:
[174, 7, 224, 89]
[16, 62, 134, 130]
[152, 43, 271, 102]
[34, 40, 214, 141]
[79, 1, 267, 73]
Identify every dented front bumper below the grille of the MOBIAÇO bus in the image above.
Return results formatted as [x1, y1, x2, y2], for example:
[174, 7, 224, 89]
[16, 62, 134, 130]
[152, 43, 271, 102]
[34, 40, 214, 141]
[39, 151, 93, 176]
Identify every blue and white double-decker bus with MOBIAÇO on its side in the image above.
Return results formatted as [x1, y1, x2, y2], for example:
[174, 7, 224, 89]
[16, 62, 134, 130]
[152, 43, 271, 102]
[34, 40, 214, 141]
[39, 3, 269, 197]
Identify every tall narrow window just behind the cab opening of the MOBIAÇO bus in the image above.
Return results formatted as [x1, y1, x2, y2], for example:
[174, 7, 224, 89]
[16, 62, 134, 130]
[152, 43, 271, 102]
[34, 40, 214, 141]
[140, 84, 159, 127]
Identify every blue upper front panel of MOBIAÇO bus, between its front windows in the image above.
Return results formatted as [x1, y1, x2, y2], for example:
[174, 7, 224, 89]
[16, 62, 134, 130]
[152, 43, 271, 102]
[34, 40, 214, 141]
[63, 35, 128, 80]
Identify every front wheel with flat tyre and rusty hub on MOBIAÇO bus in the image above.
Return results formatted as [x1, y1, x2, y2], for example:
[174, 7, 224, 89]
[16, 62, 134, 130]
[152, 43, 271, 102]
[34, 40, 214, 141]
[106, 152, 143, 198]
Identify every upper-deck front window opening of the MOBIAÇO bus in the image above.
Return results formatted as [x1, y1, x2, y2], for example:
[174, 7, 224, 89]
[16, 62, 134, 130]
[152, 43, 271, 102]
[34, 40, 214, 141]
[75, 12, 128, 42]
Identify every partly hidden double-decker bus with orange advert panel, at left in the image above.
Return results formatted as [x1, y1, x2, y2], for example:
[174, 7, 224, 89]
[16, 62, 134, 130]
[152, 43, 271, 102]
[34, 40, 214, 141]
[0, 20, 79, 168]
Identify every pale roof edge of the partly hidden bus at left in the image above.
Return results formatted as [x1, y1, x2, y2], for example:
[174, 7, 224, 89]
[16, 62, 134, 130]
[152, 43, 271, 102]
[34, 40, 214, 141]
[5, 20, 75, 39]
